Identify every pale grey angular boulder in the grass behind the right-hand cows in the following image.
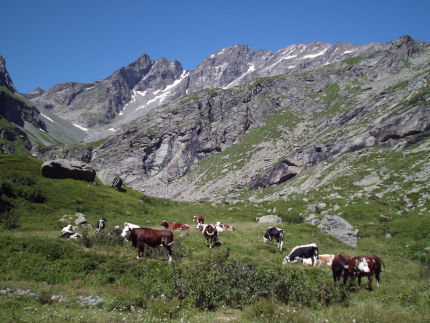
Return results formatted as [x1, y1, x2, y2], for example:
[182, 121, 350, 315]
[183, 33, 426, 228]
[318, 215, 358, 247]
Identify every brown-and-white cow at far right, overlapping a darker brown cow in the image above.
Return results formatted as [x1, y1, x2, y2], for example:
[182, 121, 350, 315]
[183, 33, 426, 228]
[344, 256, 385, 289]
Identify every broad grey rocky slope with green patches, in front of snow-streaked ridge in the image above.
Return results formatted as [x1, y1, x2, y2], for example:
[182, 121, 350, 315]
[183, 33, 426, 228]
[37, 37, 430, 201]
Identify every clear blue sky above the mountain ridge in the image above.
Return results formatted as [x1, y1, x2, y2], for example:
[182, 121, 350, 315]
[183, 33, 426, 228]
[0, 0, 430, 93]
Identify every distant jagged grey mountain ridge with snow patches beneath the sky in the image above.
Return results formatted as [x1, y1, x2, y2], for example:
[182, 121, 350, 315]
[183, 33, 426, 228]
[25, 42, 384, 141]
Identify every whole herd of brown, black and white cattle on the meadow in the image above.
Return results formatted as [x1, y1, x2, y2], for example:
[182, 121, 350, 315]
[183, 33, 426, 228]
[60, 216, 385, 289]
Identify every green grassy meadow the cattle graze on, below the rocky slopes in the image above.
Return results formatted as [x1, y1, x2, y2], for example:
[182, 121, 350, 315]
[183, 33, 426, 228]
[0, 156, 430, 322]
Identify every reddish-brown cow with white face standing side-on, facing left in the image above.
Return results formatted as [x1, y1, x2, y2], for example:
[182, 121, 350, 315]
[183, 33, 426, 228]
[121, 226, 173, 263]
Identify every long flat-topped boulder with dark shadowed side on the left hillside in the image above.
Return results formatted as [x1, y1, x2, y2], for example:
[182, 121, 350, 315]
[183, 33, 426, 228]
[41, 159, 96, 182]
